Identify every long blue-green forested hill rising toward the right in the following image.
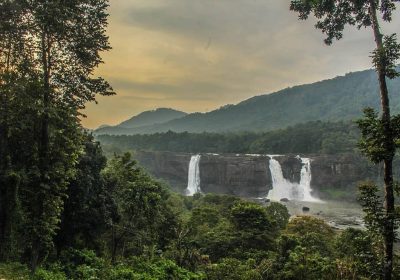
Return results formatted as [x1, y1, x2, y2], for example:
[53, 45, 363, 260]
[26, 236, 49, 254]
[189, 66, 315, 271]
[96, 66, 400, 134]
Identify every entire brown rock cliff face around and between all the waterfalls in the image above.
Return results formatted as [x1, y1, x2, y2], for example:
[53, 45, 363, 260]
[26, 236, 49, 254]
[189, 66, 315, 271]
[134, 152, 379, 198]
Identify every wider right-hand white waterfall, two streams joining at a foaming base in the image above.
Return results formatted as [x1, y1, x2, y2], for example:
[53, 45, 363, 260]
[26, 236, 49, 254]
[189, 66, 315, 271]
[267, 155, 320, 202]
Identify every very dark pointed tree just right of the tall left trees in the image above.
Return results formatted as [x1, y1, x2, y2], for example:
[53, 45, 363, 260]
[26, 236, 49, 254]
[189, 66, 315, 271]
[55, 135, 111, 255]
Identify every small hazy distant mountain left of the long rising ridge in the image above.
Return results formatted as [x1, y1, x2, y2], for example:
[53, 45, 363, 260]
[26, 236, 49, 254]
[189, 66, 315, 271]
[95, 108, 187, 134]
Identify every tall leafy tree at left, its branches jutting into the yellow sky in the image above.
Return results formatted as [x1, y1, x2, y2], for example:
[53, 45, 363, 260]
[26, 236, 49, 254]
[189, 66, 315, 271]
[25, 0, 113, 268]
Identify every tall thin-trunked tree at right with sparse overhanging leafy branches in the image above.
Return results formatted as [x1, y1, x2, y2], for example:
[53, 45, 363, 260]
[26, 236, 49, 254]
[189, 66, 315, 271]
[290, 0, 400, 279]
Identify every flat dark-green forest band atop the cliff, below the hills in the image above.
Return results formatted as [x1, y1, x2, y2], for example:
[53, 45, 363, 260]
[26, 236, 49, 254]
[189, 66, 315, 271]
[96, 121, 360, 155]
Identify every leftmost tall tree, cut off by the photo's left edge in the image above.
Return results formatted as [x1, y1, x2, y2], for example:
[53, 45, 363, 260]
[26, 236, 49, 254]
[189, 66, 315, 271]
[0, 1, 30, 259]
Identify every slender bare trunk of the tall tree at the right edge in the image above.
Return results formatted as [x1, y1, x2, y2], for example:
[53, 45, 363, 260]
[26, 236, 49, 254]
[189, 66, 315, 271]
[370, 0, 395, 280]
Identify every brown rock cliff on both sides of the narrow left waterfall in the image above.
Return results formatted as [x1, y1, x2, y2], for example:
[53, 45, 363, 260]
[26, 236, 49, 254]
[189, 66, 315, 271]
[134, 152, 272, 197]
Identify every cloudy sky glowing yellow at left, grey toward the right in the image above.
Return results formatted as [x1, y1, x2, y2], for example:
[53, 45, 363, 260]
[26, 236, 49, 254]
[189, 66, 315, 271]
[83, 0, 400, 128]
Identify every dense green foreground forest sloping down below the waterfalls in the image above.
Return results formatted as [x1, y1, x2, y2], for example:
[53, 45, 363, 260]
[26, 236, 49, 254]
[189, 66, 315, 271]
[0, 145, 400, 280]
